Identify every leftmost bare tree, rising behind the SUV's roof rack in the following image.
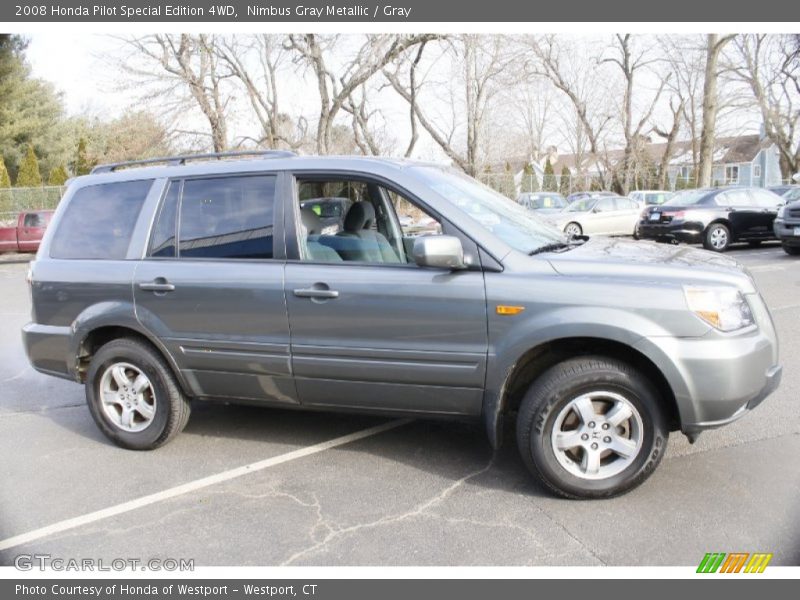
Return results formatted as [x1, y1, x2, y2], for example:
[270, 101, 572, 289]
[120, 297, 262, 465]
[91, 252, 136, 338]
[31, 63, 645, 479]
[122, 34, 231, 152]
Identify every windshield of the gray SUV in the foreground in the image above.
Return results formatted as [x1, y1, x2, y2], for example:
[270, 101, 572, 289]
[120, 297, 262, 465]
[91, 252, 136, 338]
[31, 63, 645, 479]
[410, 167, 566, 253]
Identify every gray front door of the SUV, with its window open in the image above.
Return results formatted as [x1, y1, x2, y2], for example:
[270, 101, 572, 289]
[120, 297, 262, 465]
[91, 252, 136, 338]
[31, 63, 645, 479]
[286, 174, 488, 415]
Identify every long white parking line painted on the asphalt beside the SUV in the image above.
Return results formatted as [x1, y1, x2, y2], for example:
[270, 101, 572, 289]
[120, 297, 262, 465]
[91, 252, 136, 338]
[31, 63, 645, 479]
[0, 419, 411, 550]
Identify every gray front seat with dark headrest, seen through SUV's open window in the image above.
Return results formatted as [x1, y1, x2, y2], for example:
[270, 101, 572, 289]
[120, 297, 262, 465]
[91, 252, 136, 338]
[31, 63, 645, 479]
[320, 202, 401, 263]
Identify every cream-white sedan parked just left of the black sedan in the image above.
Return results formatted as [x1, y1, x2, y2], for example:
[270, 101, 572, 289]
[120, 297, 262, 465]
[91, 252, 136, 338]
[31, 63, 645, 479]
[545, 196, 641, 237]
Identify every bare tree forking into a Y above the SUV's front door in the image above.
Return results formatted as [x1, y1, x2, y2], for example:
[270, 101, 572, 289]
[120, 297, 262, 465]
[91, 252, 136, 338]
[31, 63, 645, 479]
[286, 33, 438, 154]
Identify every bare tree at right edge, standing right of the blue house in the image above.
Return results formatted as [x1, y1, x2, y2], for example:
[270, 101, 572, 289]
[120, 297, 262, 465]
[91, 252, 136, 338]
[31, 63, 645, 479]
[728, 34, 800, 179]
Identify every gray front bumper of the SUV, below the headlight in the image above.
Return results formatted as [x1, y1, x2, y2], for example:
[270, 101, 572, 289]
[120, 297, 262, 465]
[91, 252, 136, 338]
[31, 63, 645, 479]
[637, 294, 782, 433]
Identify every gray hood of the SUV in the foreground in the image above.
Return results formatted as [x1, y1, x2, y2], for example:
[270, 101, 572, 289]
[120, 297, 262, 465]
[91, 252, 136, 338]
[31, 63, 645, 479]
[547, 236, 756, 294]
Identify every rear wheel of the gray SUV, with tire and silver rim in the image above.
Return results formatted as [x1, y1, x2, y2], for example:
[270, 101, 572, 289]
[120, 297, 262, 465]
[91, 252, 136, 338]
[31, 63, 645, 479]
[86, 339, 190, 450]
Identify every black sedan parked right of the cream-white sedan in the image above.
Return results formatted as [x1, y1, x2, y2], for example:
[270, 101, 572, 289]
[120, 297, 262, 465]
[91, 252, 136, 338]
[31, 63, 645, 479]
[638, 187, 784, 252]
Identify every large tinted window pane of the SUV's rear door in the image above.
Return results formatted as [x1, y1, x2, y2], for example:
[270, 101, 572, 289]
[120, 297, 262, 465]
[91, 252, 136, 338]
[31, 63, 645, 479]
[178, 175, 275, 259]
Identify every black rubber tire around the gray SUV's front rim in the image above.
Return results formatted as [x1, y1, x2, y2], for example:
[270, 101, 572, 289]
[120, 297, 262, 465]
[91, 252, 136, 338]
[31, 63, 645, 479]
[517, 356, 669, 499]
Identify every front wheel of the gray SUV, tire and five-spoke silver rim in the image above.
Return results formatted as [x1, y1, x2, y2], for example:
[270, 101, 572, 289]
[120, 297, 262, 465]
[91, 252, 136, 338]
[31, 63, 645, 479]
[517, 357, 669, 498]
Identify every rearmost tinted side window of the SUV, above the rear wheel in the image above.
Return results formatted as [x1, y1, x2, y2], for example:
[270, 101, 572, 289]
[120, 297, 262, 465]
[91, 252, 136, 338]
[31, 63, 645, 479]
[50, 179, 153, 260]
